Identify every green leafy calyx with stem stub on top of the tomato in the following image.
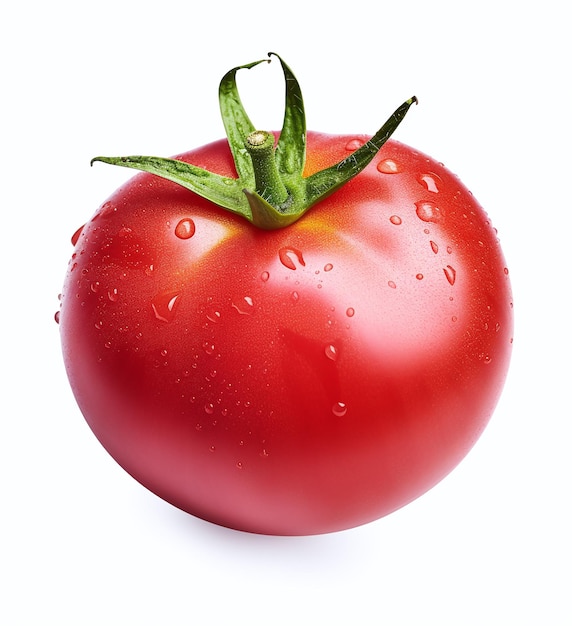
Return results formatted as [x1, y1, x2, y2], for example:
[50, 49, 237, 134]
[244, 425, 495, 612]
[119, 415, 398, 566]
[91, 52, 417, 230]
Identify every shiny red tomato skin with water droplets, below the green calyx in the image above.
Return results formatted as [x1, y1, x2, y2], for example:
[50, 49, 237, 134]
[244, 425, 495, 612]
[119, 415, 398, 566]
[59, 133, 513, 535]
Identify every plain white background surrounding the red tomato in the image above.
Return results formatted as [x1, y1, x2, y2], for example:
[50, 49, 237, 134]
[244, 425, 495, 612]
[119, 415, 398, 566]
[0, 0, 572, 626]
